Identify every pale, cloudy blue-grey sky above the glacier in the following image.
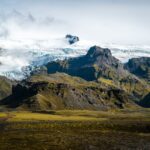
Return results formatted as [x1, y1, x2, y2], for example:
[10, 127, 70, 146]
[0, 0, 150, 45]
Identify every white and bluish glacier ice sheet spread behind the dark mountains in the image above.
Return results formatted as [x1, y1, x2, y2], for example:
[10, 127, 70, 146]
[0, 37, 150, 80]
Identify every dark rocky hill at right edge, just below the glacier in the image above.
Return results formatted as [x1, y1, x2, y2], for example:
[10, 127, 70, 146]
[125, 57, 150, 81]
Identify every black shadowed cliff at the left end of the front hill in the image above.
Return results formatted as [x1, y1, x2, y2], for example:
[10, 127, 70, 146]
[0, 81, 47, 108]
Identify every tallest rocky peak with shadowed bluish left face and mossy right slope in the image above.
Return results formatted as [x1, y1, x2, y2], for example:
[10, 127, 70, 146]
[46, 46, 150, 100]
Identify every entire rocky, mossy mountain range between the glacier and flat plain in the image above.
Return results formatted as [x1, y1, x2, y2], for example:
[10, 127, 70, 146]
[0, 43, 150, 111]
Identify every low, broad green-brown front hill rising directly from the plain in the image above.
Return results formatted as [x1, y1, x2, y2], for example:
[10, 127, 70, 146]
[0, 73, 137, 111]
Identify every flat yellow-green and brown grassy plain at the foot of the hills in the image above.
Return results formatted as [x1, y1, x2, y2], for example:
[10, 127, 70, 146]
[0, 109, 150, 150]
